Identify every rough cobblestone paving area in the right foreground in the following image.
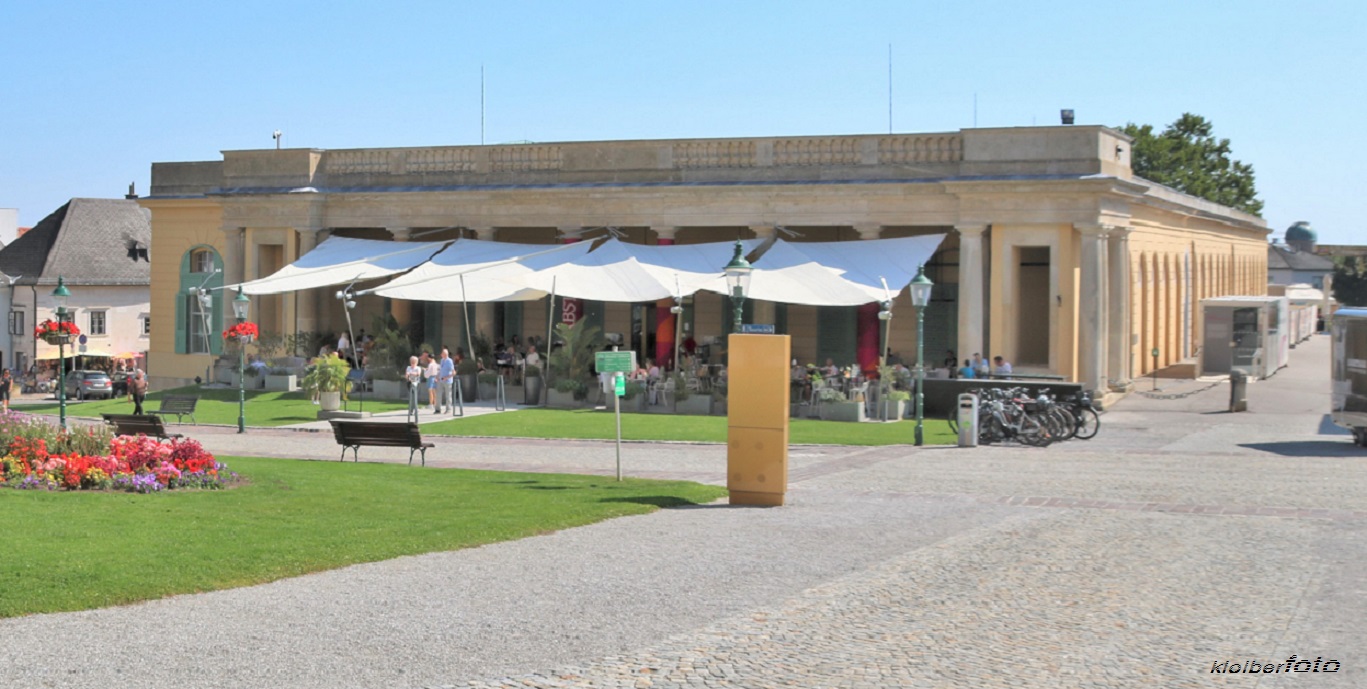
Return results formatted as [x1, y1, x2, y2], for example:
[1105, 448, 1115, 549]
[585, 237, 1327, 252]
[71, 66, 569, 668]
[440, 510, 1360, 689]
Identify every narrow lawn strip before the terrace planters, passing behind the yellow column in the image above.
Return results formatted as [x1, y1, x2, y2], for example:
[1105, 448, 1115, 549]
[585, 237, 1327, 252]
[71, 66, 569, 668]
[422, 409, 957, 446]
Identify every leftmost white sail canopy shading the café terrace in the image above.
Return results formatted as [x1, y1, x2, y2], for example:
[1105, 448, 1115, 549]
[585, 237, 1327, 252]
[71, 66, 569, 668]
[227, 237, 448, 295]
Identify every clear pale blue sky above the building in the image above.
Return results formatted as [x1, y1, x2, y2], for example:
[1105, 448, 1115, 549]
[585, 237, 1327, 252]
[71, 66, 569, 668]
[0, 0, 1367, 243]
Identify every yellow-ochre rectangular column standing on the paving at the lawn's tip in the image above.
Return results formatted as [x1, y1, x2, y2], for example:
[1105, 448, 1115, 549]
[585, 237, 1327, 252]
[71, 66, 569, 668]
[726, 334, 791, 506]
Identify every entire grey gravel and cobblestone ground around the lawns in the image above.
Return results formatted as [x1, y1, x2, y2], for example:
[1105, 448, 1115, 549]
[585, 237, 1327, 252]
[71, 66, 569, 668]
[0, 338, 1367, 689]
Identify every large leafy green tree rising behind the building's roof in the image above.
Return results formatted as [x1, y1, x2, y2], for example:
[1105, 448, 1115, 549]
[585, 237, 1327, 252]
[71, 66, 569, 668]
[1121, 112, 1263, 215]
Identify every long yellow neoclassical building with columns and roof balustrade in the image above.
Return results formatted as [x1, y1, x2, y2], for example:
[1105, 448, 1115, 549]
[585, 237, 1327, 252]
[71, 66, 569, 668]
[141, 126, 1267, 391]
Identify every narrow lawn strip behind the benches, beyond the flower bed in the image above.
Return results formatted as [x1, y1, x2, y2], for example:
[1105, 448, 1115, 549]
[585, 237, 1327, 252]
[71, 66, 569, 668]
[15, 386, 407, 427]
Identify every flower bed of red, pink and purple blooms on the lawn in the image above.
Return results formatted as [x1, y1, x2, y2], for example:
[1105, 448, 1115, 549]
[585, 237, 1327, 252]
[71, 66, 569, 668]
[0, 413, 236, 494]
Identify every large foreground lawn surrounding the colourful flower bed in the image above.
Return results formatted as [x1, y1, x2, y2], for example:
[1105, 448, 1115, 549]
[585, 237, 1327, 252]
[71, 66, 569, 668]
[0, 457, 726, 618]
